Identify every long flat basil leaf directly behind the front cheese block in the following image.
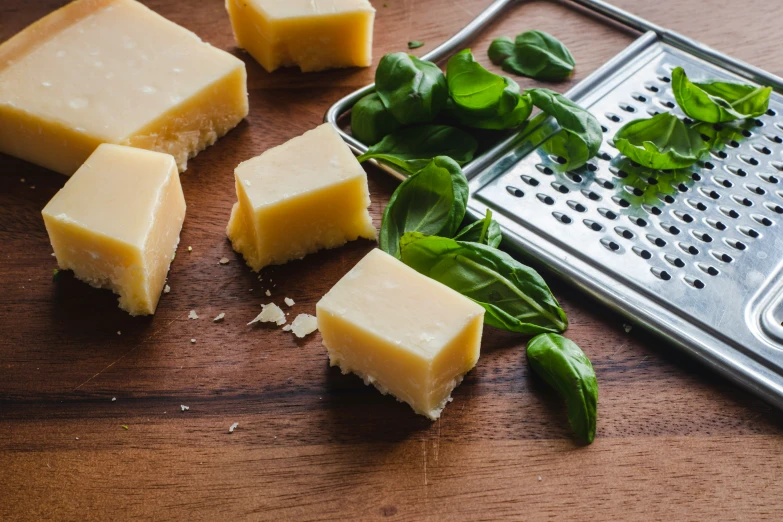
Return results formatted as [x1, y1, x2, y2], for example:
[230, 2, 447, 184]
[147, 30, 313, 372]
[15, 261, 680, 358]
[400, 232, 568, 334]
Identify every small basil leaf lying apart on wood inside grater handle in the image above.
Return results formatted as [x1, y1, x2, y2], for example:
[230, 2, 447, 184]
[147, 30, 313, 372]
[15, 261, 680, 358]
[489, 31, 575, 80]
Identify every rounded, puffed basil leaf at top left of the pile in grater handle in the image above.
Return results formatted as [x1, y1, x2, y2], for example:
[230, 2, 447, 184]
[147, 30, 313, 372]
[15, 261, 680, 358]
[375, 53, 449, 125]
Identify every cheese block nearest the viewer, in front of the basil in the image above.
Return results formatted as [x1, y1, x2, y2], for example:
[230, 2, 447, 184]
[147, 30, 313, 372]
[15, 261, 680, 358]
[316, 249, 484, 419]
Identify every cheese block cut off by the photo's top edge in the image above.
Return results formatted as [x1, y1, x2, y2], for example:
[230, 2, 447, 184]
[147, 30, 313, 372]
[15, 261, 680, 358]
[226, 0, 375, 72]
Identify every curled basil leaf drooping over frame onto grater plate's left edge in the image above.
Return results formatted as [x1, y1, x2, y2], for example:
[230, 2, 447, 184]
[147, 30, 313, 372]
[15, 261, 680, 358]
[525, 89, 604, 169]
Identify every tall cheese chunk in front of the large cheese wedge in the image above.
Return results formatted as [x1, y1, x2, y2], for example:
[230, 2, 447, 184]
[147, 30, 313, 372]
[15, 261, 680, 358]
[43, 144, 185, 315]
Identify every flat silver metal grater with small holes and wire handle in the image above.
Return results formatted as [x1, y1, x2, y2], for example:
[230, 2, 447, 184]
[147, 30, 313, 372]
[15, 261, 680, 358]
[325, 0, 783, 407]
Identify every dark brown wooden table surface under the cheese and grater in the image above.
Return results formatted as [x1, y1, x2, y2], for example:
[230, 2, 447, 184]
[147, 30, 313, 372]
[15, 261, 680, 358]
[0, 0, 783, 521]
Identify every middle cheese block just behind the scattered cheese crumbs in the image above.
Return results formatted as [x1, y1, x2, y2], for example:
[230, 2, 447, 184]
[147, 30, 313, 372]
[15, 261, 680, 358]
[226, 123, 376, 271]
